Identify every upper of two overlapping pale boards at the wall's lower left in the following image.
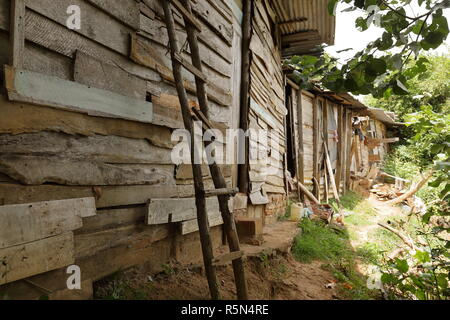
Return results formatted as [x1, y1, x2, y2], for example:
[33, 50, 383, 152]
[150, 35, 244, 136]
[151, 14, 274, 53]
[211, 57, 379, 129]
[0, 198, 96, 249]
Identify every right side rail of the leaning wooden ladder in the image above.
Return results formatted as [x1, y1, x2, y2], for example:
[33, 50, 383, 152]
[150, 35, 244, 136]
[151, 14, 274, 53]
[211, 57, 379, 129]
[179, 0, 249, 300]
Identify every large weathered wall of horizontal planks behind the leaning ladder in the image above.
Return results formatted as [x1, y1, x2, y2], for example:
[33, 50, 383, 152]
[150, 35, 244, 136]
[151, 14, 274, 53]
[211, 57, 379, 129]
[0, 0, 238, 297]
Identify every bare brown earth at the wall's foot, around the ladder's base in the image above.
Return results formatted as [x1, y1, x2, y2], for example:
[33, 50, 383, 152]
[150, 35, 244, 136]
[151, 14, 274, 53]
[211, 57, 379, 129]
[95, 221, 339, 300]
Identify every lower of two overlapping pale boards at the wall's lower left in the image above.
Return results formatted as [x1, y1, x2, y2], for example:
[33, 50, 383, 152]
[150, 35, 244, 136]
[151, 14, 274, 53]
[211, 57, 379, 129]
[0, 232, 75, 285]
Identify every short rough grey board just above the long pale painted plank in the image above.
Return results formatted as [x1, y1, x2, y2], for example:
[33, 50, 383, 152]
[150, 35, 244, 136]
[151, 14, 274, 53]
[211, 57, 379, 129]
[74, 51, 147, 101]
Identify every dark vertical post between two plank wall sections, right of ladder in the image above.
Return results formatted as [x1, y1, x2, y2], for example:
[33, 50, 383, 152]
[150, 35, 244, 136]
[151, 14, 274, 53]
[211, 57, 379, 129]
[238, 0, 253, 193]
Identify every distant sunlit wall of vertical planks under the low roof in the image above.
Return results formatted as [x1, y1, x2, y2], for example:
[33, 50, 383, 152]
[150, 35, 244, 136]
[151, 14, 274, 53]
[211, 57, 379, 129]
[292, 88, 353, 199]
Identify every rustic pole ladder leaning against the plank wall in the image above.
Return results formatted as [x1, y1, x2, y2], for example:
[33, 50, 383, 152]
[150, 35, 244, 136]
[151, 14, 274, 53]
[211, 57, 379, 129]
[160, 0, 248, 300]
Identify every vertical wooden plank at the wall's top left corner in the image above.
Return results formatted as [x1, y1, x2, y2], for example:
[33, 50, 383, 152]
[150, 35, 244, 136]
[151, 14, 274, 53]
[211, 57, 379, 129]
[10, 0, 25, 68]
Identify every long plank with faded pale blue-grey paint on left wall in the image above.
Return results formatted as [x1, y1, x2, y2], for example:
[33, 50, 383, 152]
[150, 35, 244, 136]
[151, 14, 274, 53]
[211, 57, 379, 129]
[5, 66, 153, 123]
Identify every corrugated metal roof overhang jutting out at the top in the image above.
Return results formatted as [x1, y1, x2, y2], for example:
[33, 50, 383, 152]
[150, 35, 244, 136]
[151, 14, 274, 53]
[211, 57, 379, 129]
[271, 0, 336, 56]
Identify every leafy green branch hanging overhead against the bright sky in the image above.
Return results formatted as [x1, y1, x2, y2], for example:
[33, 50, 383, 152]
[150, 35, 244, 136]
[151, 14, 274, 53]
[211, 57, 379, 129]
[285, 0, 450, 97]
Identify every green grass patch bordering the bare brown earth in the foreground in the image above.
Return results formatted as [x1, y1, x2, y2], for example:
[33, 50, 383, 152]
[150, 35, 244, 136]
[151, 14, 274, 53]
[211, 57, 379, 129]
[292, 219, 376, 300]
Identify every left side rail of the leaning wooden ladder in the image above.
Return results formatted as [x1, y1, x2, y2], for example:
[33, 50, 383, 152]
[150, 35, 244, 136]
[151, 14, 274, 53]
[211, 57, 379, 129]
[161, 0, 220, 300]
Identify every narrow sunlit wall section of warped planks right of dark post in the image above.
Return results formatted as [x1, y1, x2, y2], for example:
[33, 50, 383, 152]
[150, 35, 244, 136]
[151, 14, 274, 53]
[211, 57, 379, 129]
[249, 0, 287, 220]
